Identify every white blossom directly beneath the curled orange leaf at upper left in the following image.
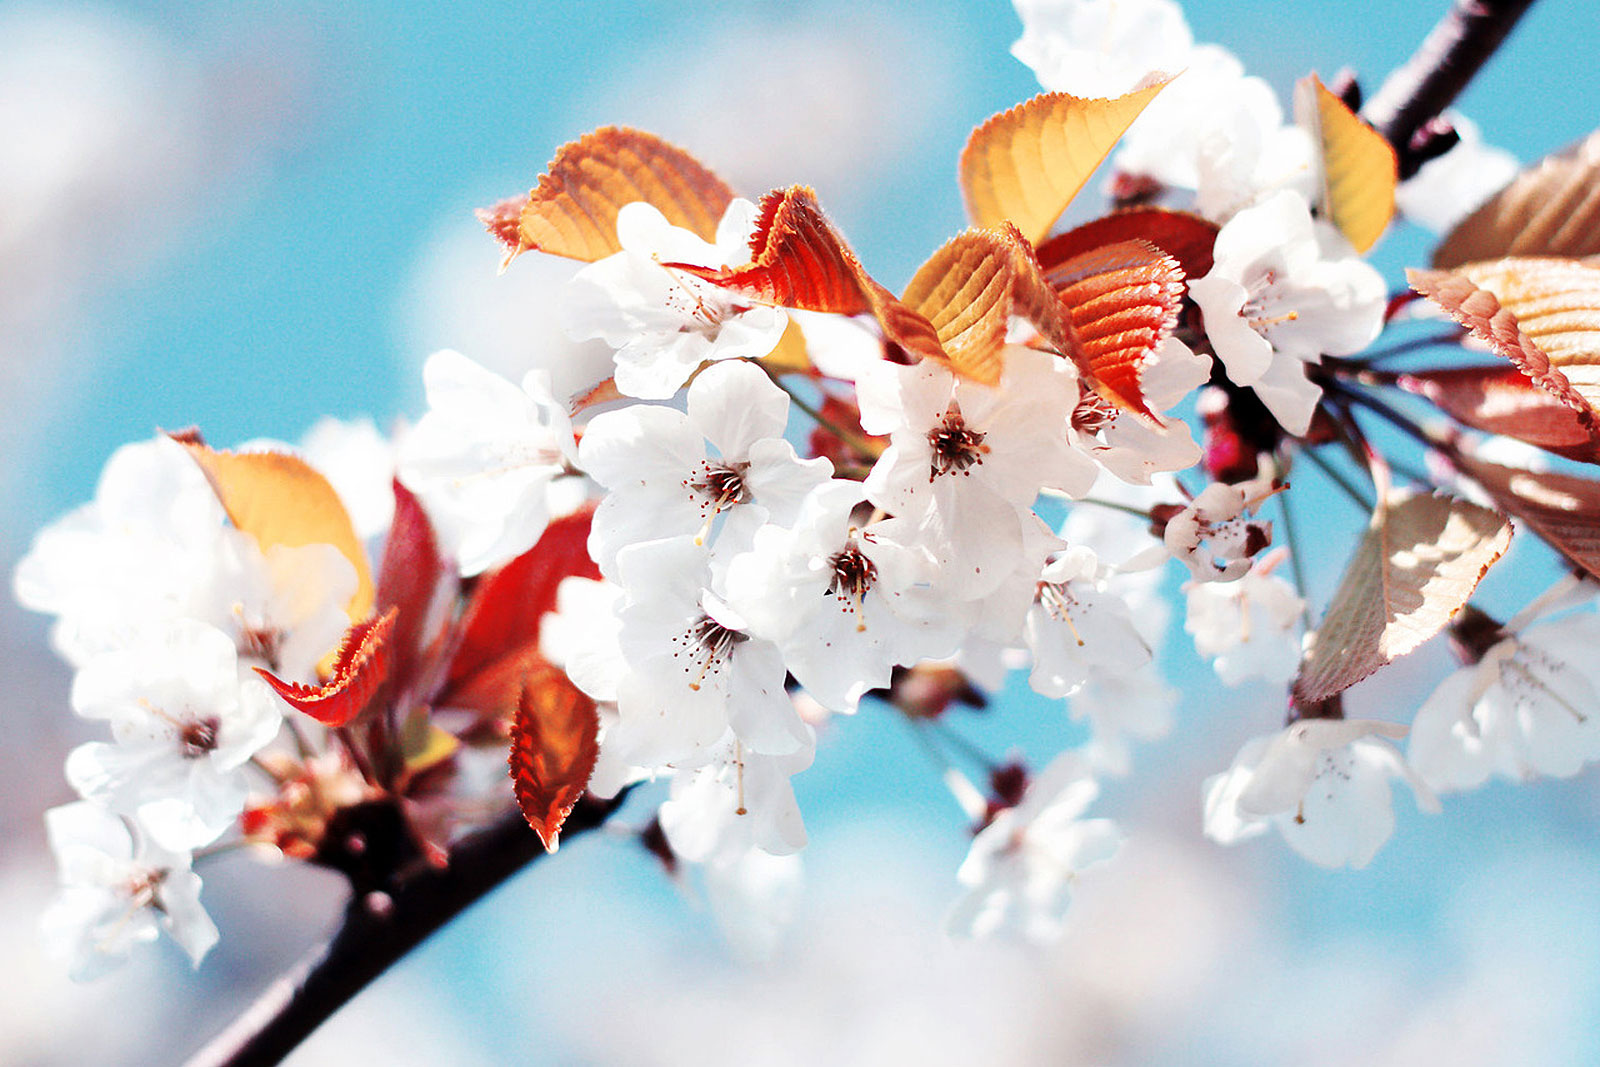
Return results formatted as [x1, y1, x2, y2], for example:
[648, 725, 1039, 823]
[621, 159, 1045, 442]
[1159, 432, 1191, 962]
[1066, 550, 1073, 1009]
[563, 200, 789, 400]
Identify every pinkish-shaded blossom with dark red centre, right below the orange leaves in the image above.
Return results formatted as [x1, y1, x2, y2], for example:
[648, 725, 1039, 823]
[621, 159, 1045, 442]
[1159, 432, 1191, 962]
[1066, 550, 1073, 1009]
[858, 346, 1094, 600]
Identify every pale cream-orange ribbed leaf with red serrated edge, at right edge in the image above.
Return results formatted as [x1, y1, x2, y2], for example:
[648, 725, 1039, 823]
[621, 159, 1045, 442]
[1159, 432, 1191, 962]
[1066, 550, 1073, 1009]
[1406, 259, 1600, 434]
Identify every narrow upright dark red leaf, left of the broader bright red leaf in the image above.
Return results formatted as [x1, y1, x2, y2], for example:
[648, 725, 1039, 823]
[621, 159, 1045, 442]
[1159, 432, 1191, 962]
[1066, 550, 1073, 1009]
[378, 478, 456, 686]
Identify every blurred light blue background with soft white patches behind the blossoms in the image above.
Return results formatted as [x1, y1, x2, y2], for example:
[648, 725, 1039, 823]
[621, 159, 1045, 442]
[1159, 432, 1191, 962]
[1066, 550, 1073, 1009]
[0, 0, 1600, 1065]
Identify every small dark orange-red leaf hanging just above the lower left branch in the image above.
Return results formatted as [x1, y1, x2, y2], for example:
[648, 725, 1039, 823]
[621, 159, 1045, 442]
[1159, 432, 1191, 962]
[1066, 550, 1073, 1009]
[509, 665, 600, 853]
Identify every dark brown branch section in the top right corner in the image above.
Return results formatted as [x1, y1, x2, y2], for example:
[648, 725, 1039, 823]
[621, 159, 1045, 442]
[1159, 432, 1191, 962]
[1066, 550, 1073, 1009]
[1362, 0, 1533, 178]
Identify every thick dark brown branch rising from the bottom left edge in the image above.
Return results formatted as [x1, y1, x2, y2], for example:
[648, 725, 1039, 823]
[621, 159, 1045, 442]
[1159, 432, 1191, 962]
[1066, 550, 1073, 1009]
[187, 798, 621, 1067]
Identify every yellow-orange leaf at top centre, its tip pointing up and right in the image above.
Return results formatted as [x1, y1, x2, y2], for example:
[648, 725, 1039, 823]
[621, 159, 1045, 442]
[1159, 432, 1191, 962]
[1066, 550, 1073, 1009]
[960, 82, 1166, 243]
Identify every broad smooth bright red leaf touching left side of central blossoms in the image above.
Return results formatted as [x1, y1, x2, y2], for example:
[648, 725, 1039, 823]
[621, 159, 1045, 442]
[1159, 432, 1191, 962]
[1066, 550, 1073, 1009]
[438, 504, 600, 712]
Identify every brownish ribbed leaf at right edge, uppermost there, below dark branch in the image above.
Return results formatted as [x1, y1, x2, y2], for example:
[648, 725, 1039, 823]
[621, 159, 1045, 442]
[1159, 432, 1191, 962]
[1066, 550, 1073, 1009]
[1434, 130, 1600, 267]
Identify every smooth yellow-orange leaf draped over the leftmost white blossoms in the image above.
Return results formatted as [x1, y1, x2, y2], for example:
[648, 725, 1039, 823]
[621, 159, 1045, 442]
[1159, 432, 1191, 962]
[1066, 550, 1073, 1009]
[174, 435, 373, 622]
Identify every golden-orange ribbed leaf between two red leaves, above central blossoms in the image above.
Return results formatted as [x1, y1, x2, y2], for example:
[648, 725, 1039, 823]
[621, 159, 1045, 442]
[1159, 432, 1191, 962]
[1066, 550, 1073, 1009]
[902, 222, 1072, 386]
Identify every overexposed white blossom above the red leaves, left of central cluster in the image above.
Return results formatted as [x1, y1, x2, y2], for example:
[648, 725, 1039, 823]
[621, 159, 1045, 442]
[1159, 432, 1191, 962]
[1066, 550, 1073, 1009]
[398, 350, 574, 576]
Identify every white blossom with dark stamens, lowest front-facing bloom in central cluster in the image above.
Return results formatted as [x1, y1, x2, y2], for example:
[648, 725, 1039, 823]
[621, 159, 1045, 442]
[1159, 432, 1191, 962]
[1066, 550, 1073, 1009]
[606, 536, 811, 766]
